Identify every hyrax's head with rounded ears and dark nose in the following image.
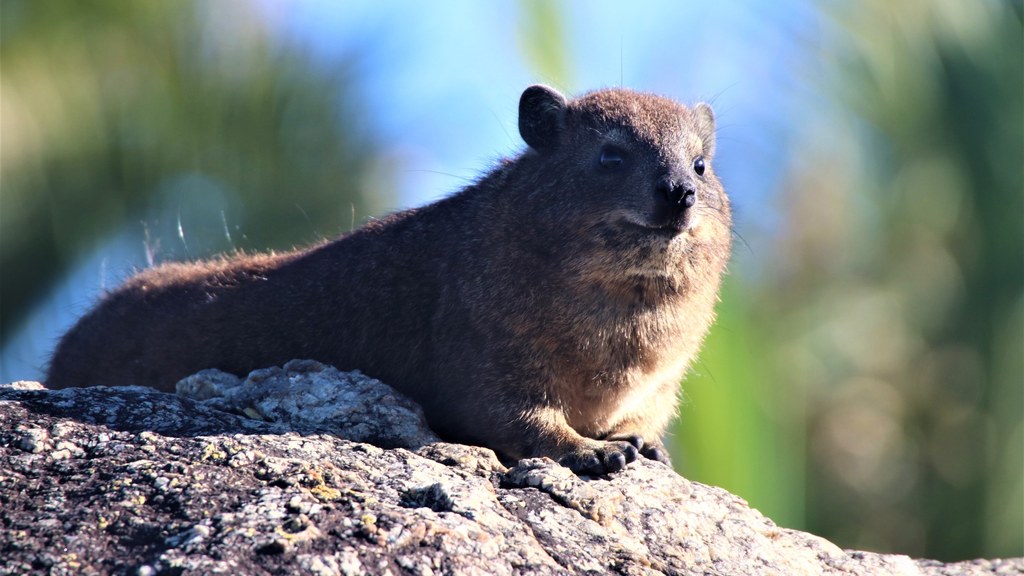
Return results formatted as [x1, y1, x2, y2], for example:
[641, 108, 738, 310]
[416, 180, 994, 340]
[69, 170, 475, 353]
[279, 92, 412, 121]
[519, 86, 729, 242]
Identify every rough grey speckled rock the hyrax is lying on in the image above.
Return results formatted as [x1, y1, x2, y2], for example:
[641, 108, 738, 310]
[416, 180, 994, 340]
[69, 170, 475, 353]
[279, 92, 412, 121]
[0, 362, 1024, 575]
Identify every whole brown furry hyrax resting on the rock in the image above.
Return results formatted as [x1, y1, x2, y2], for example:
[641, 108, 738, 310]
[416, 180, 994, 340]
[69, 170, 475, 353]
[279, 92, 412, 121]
[47, 86, 731, 472]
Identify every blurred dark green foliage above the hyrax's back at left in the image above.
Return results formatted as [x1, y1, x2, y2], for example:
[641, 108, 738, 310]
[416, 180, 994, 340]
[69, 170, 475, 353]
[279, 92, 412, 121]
[0, 0, 384, 344]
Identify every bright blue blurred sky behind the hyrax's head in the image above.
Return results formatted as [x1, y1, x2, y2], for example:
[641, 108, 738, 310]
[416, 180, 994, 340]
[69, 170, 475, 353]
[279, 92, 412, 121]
[251, 0, 814, 212]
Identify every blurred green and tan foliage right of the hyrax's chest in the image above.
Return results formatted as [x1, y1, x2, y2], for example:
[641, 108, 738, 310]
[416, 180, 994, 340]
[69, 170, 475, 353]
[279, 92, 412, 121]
[677, 0, 1024, 560]
